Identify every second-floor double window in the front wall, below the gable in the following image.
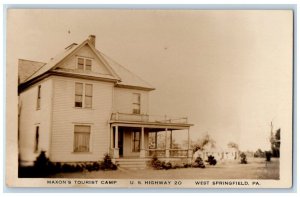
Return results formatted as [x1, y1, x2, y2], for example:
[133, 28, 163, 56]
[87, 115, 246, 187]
[75, 83, 93, 108]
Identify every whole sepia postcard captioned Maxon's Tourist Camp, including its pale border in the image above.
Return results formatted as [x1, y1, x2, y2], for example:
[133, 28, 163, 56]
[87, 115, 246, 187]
[6, 8, 294, 188]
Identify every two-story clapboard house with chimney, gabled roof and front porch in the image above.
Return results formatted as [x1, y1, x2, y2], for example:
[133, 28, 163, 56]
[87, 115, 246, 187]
[18, 35, 192, 168]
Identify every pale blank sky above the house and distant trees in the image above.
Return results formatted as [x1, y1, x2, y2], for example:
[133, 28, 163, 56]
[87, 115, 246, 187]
[6, 9, 293, 150]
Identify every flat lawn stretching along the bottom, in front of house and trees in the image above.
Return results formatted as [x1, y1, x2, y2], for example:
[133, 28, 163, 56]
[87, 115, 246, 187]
[50, 158, 279, 180]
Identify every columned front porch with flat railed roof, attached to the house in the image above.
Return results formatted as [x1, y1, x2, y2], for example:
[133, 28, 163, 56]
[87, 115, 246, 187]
[110, 113, 192, 161]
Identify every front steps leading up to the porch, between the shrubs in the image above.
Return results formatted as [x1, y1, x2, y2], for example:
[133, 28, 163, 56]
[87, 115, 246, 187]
[116, 158, 148, 170]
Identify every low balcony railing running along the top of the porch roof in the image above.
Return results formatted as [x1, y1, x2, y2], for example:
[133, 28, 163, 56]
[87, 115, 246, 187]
[111, 112, 188, 124]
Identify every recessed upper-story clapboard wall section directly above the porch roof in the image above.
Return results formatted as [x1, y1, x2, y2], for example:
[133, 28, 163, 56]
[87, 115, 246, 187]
[114, 87, 149, 114]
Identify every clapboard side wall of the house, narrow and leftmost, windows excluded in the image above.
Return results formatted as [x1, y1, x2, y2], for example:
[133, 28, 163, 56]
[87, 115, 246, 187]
[19, 78, 52, 165]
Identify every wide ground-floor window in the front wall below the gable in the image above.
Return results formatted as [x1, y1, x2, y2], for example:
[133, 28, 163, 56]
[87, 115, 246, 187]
[74, 125, 91, 152]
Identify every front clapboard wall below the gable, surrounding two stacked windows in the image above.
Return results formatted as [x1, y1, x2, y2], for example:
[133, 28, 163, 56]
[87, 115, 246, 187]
[50, 77, 113, 162]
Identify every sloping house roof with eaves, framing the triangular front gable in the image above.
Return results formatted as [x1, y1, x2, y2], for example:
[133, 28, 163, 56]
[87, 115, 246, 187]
[19, 35, 154, 90]
